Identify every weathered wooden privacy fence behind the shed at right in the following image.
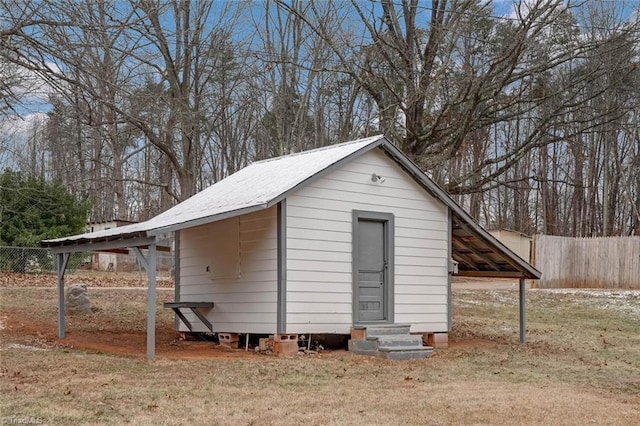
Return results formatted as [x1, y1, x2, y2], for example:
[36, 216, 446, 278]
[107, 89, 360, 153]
[534, 235, 640, 289]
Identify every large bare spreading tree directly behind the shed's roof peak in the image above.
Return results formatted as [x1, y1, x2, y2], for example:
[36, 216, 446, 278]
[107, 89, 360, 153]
[278, 0, 632, 193]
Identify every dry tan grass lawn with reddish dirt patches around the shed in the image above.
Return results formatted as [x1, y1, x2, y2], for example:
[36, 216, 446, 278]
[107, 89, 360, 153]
[0, 278, 640, 425]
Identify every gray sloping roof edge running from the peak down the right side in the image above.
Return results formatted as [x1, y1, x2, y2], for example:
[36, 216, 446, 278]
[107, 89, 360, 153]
[378, 140, 542, 279]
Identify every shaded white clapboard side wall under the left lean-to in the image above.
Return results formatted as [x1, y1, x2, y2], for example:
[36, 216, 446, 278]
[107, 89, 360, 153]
[180, 207, 278, 333]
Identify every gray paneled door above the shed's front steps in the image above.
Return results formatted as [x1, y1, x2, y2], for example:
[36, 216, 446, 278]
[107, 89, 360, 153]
[354, 218, 389, 322]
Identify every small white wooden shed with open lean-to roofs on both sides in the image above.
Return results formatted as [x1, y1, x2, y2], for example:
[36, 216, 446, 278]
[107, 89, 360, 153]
[43, 136, 540, 358]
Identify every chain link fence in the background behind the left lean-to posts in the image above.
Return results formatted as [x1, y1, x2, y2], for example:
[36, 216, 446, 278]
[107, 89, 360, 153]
[0, 246, 173, 274]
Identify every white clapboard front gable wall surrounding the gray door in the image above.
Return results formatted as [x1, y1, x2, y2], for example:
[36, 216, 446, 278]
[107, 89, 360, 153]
[286, 150, 448, 333]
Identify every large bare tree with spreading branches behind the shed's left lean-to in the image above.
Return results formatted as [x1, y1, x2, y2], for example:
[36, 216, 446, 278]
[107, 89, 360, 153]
[2, 0, 252, 210]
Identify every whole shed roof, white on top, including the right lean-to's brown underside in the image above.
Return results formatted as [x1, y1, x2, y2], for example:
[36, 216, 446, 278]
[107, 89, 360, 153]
[42, 135, 540, 278]
